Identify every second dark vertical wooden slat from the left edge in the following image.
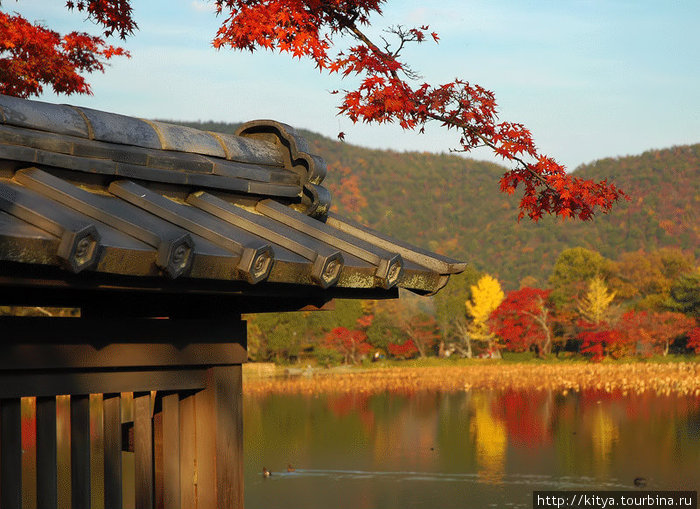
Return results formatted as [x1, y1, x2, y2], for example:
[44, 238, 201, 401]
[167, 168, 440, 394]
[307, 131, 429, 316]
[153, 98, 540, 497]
[36, 396, 58, 509]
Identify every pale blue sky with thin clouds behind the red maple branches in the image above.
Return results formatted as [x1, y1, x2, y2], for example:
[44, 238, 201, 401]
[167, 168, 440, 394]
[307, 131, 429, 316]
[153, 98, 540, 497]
[2, 0, 700, 169]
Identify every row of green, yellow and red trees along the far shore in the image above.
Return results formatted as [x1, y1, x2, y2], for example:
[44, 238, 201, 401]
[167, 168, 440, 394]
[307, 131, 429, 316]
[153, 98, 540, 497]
[249, 247, 700, 365]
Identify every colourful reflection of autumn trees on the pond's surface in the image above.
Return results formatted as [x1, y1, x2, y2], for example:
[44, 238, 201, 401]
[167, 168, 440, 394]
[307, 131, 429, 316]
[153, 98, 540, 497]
[244, 390, 700, 489]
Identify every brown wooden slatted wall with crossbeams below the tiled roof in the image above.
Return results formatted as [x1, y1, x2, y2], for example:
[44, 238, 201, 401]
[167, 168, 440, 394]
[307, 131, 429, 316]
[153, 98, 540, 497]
[0, 318, 245, 509]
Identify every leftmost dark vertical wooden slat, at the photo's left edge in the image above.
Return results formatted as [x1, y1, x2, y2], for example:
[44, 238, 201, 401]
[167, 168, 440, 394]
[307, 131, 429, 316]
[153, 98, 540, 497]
[0, 398, 22, 509]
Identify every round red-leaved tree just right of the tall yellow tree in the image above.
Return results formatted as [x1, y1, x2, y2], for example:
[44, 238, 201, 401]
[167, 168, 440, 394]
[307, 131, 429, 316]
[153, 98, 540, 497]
[489, 286, 552, 355]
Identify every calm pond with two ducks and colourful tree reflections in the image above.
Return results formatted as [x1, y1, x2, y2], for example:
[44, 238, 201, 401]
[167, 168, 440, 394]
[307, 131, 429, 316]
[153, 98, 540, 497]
[244, 390, 700, 509]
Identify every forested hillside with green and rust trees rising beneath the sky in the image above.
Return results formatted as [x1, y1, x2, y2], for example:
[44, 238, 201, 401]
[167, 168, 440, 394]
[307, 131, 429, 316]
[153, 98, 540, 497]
[176, 123, 700, 288]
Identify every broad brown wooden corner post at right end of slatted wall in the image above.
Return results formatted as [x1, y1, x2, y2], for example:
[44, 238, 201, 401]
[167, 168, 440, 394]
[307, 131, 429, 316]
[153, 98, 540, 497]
[195, 365, 243, 509]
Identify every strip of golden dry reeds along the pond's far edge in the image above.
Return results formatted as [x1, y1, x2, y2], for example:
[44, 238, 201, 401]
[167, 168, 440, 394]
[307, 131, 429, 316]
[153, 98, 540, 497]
[243, 363, 700, 397]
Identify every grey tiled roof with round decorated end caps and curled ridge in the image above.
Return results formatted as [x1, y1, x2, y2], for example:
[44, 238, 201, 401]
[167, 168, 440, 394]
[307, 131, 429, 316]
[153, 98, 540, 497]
[0, 95, 465, 293]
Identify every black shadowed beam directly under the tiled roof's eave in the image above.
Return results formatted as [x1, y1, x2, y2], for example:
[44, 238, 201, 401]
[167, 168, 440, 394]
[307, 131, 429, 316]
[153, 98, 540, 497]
[0, 262, 399, 310]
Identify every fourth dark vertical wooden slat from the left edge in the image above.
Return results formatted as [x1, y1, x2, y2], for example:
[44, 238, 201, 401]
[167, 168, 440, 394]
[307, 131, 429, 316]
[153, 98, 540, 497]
[102, 394, 122, 509]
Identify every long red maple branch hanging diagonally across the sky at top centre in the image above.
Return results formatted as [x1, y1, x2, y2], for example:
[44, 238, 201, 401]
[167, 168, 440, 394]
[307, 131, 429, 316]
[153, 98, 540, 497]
[214, 0, 624, 221]
